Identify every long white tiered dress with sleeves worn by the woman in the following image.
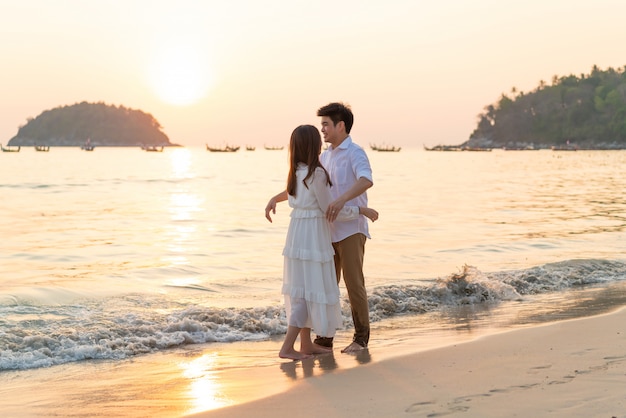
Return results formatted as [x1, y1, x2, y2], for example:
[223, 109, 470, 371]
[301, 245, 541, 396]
[282, 163, 359, 337]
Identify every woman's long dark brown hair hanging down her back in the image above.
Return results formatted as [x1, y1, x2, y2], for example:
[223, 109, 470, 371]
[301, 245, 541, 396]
[287, 125, 332, 197]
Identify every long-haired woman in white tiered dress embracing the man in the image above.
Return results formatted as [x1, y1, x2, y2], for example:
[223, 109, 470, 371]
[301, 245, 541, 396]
[266, 125, 378, 360]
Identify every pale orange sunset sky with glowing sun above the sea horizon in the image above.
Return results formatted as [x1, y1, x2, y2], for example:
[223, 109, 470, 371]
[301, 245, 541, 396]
[0, 0, 626, 147]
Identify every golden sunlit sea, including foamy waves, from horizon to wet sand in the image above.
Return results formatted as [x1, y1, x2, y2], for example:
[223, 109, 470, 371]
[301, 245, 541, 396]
[0, 147, 626, 414]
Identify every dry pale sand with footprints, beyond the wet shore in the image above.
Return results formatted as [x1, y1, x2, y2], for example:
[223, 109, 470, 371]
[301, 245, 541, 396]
[194, 309, 626, 418]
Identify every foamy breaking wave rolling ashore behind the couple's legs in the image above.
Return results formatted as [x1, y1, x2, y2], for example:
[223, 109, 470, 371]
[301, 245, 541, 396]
[0, 260, 626, 370]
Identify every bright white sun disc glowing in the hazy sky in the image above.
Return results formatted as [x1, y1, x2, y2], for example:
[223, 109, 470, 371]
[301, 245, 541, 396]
[148, 41, 213, 106]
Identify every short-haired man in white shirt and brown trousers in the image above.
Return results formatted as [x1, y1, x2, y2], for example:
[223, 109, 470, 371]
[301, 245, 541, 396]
[265, 103, 374, 353]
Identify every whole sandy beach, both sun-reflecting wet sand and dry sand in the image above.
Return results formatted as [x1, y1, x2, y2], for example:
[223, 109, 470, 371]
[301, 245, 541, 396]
[0, 303, 626, 418]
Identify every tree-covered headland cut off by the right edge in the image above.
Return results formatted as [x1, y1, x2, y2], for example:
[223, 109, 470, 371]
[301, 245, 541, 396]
[462, 65, 626, 149]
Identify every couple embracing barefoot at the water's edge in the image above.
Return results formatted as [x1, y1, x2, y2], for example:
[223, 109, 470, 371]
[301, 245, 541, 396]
[265, 103, 378, 360]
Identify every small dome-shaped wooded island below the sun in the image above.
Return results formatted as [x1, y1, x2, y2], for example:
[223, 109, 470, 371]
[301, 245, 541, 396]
[8, 102, 174, 147]
